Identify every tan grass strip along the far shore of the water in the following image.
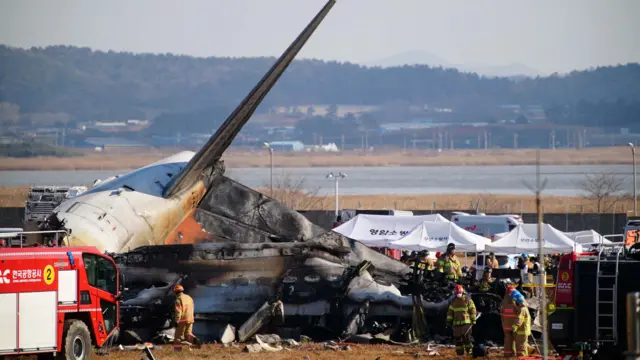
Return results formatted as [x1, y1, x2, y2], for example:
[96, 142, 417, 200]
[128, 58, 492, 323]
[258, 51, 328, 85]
[0, 147, 632, 171]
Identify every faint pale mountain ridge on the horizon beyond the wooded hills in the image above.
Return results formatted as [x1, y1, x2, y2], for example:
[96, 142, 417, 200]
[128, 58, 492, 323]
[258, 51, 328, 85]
[363, 51, 542, 77]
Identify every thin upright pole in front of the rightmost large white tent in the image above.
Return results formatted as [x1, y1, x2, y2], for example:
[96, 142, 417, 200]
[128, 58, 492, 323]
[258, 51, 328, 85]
[525, 149, 549, 360]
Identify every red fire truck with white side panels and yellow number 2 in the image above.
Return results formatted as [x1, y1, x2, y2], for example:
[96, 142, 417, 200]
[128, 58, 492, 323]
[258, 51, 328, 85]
[0, 247, 123, 360]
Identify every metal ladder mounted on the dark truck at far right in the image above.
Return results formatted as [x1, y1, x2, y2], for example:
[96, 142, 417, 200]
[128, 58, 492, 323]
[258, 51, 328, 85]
[596, 246, 624, 345]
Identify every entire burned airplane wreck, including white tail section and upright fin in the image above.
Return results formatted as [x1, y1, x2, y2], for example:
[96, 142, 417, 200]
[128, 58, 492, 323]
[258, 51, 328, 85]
[35, 0, 516, 348]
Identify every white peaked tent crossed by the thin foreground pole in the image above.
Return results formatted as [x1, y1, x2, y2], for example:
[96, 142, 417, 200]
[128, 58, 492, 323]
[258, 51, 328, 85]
[485, 224, 582, 254]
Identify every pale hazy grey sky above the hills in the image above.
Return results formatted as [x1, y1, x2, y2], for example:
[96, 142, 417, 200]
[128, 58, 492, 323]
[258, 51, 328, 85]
[0, 0, 640, 73]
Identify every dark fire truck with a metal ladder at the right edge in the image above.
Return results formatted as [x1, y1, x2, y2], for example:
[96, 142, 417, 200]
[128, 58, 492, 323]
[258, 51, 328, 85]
[548, 243, 640, 358]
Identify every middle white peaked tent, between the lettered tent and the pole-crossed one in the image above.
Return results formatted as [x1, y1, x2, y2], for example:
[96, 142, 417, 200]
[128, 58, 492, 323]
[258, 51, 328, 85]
[389, 222, 491, 252]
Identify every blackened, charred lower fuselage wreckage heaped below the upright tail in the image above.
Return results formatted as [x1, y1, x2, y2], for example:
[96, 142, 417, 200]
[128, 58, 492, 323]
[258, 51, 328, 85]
[114, 176, 504, 342]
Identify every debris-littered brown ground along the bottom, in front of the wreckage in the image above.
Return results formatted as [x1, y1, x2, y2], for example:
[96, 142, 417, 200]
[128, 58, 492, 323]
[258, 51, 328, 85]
[105, 344, 516, 360]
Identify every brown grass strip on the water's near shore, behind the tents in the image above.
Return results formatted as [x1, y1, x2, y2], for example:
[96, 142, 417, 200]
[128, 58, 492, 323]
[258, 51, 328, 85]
[0, 185, 633, 214]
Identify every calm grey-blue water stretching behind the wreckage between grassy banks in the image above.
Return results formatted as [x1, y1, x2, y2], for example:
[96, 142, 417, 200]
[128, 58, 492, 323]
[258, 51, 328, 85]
[0, 165, 633, 196]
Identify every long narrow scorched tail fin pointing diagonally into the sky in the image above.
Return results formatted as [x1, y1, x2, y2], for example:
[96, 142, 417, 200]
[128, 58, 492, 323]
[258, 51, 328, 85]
[164, 0, 336, 197]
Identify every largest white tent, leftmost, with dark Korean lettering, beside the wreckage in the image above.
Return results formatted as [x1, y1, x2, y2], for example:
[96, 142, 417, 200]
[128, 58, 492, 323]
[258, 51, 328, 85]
[333, 214, 449, 247]
